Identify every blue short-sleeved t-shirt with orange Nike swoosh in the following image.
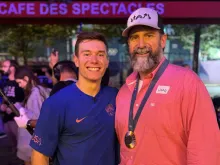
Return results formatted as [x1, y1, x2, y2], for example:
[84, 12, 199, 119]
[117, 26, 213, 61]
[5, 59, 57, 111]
[30, 84, 118, 165]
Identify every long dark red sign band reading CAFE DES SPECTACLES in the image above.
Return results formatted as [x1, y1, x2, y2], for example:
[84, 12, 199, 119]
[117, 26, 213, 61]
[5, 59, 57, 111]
[0, 1, 220, 18]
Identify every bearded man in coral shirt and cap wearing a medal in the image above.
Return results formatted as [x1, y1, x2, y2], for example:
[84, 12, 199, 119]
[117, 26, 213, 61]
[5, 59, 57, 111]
[116, 8, 220, 165]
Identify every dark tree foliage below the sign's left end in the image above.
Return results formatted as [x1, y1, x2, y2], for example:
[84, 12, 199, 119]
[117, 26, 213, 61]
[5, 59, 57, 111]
[0, 24, 74, 64]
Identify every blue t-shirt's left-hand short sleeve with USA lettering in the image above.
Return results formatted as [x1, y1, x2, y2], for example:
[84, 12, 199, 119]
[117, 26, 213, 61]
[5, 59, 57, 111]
[30, 98, 64, 156]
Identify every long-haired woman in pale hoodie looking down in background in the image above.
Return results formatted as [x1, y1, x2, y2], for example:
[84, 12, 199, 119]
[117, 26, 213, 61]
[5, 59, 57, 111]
[4, 67, 50, 165]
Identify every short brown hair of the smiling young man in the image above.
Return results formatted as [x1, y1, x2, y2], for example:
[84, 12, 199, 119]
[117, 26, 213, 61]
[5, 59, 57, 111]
[75, 32, 108, 56]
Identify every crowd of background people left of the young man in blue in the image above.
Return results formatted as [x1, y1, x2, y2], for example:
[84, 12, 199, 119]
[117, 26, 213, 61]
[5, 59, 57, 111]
[0, 52, 77, 165]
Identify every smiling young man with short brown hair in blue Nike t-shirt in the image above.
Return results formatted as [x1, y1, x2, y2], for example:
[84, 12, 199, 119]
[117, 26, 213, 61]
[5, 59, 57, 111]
[30, 32, 117, 165]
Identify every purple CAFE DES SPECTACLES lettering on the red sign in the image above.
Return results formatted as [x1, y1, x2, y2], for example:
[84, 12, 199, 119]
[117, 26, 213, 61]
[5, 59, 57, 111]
[0, 2, 164, 17]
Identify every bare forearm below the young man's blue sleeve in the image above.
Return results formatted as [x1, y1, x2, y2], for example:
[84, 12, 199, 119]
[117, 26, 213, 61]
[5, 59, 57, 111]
[31, 149, 49, 165]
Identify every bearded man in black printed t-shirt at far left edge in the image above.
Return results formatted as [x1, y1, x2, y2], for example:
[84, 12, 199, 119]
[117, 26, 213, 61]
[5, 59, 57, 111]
[0, 60, 24, 165]
